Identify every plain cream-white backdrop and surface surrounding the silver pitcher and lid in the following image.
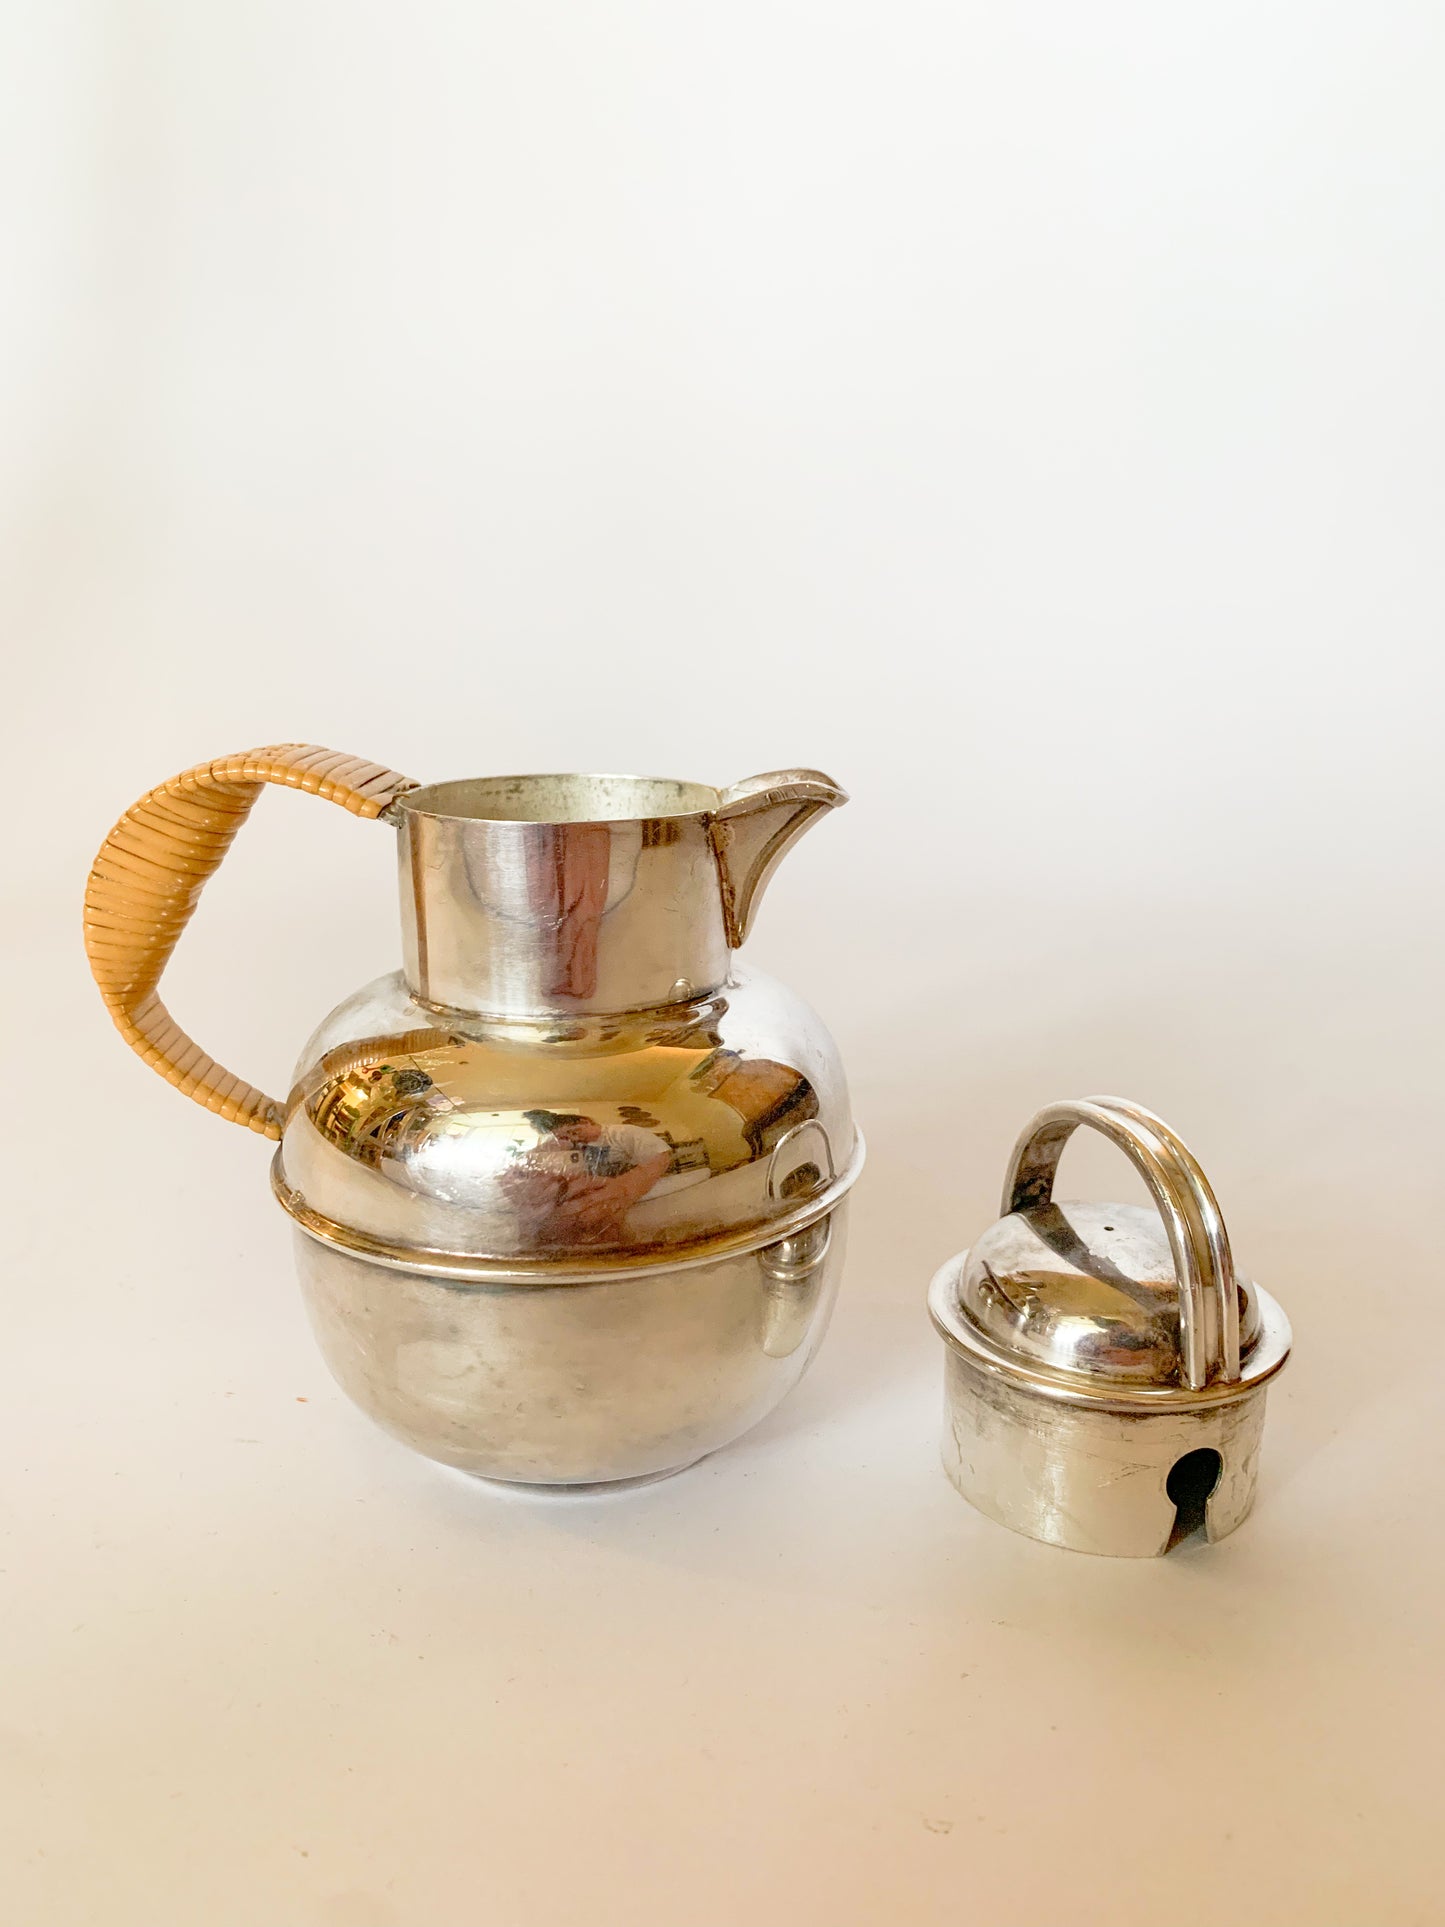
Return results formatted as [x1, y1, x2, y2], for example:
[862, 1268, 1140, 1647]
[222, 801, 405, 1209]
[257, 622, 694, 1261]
[0, 0, 1445, 1927]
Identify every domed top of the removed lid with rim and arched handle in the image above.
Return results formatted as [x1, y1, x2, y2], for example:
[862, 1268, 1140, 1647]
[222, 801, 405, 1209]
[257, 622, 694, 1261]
[931, 1098, 1289, 1405]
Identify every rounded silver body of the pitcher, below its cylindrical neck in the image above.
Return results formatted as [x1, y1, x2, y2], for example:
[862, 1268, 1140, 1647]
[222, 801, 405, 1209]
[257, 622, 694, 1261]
[274, 971, 861, 1484]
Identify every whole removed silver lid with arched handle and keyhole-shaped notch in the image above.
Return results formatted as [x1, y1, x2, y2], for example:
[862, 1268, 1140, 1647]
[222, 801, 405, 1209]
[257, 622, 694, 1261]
[929, 1096, 1289, 1557]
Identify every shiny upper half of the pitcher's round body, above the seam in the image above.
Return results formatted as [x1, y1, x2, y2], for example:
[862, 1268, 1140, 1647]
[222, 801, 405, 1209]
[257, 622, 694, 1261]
[276, 977, 861, 1280]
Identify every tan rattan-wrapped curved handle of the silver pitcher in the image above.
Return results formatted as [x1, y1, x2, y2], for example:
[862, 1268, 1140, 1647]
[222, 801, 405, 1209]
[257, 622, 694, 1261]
[85, 742, 416, 1137]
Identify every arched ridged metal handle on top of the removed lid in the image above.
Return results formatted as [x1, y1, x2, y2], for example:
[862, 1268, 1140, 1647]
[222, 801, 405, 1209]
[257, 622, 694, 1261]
[1004, 1096, 1239, 1391]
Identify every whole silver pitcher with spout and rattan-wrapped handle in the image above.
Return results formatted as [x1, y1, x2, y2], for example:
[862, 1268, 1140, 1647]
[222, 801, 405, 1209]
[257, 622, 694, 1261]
[85, 744, 863, 1486]
